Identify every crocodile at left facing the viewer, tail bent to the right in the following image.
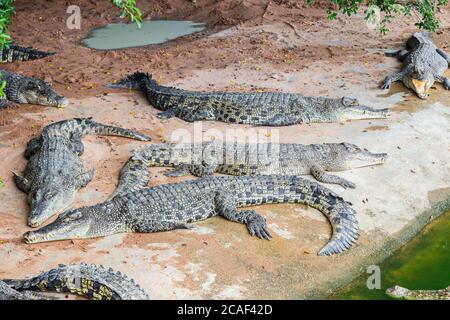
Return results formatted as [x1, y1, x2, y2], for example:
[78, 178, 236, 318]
[13, 118, 150, 227]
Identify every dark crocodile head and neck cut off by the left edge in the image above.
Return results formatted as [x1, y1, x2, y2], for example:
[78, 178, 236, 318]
[0, 70, 69, 109]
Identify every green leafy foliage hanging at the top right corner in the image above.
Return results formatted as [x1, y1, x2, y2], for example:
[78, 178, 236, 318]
[306, 0, 448, 34]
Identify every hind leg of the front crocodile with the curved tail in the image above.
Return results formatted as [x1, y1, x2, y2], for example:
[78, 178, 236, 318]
[215, 192, 272, 240]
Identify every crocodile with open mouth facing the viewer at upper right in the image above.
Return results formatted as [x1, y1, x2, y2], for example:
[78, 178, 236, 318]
[381, 32, 450, 99]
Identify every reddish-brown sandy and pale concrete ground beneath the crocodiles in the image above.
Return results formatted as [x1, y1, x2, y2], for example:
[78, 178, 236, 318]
[0, 0, 450, 299]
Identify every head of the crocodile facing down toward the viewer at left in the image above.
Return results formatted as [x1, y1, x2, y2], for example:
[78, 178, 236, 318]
[28, 176, 76, 227]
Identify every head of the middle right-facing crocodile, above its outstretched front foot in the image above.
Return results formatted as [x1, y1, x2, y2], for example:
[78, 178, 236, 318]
[323, 142, 388, 171]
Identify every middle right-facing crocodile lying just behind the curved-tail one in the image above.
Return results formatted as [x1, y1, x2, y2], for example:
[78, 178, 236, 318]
[133, 142, 388, 188]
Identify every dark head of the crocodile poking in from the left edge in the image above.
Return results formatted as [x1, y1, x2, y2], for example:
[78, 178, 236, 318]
[17, 78, 69, 108]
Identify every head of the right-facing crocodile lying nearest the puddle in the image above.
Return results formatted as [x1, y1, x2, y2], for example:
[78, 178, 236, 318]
[335, 97, 390, 121]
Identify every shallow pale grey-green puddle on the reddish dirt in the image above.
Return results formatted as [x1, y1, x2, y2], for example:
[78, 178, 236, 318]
[82, 20, 205, 50]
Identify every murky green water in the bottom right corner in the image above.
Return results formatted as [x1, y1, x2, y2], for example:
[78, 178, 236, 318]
[329, 211, 450, 300]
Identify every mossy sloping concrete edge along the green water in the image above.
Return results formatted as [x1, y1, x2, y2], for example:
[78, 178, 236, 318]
[304, 196, 450, 300]
